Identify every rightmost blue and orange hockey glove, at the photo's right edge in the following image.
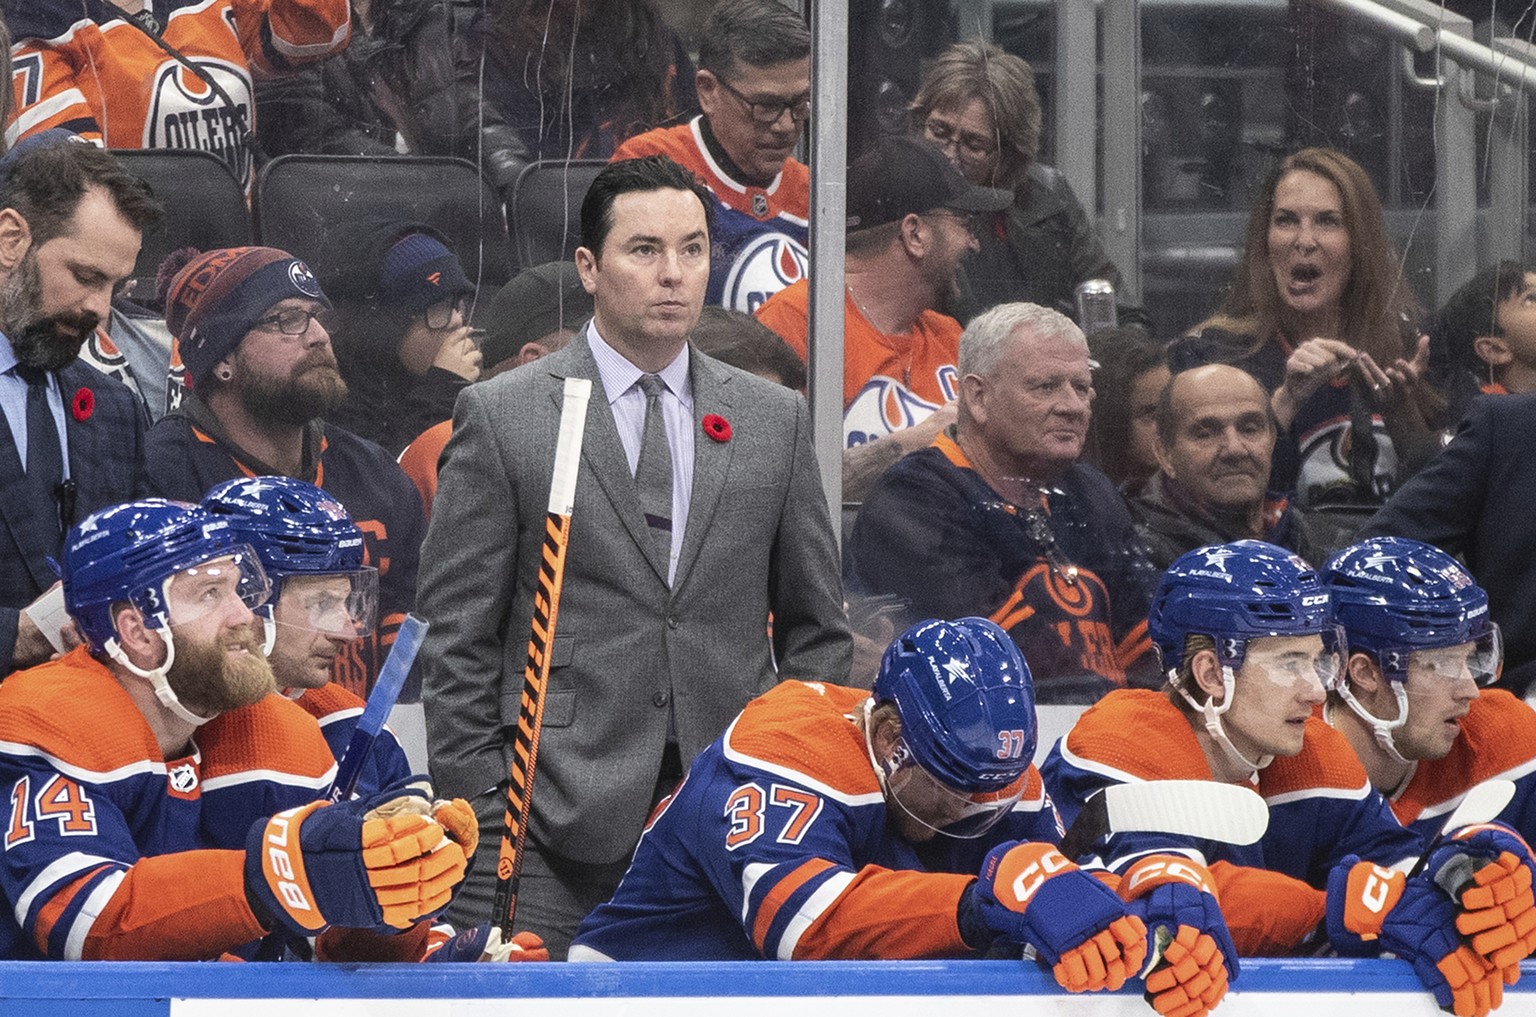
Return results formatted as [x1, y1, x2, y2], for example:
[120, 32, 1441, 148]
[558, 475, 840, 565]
[1424, 823, 1536, 985]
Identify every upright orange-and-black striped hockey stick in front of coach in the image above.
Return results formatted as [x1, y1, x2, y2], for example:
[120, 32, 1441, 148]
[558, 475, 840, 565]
[492, 378, 591, 940]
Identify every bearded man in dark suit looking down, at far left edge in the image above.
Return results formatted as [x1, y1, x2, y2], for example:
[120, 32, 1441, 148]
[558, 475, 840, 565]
[0, 132, 160, 677]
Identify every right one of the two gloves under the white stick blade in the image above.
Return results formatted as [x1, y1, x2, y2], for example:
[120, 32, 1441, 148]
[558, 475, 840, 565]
[1120, 854, 1240, 1017]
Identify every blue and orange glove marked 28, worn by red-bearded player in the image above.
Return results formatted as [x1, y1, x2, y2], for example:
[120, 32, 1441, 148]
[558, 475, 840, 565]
[246, 785, 465, 936]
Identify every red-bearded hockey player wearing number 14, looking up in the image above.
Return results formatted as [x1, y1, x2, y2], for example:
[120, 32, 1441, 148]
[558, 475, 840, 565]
[0, 499, 476, 960]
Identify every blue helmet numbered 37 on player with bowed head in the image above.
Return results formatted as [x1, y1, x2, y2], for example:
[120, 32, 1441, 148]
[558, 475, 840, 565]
[874, 618, 1037, 797]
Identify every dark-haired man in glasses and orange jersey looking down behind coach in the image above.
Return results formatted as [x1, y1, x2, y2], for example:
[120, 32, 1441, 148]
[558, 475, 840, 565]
[613, 0, 811, 313]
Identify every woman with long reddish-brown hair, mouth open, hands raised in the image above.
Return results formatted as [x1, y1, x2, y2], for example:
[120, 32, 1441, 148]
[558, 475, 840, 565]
[1169, 147, 1445, 507]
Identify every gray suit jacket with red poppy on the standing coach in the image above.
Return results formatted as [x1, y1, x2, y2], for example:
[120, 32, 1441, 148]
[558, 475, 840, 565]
[416, 336, 852, 862]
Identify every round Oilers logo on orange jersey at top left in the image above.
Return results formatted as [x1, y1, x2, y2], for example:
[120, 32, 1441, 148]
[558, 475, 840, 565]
[143, 57, 253, 183]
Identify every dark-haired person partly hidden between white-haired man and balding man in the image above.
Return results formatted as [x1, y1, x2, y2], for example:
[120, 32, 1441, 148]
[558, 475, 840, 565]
[1083, 329, 1172, 498]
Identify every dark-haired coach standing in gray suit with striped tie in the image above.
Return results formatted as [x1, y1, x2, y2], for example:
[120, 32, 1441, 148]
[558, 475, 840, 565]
[418, 155, 852, 957]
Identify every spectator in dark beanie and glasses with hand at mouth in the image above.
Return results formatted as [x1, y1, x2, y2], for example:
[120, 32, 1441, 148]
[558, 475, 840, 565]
[318, 221, 481, 455]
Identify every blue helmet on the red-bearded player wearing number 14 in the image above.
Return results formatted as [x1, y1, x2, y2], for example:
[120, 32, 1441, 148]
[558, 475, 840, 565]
[60, 498, 270, 653]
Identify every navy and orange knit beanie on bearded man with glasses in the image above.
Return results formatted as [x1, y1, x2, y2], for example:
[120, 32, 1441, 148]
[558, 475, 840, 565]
[166, 247, 330, 389]
